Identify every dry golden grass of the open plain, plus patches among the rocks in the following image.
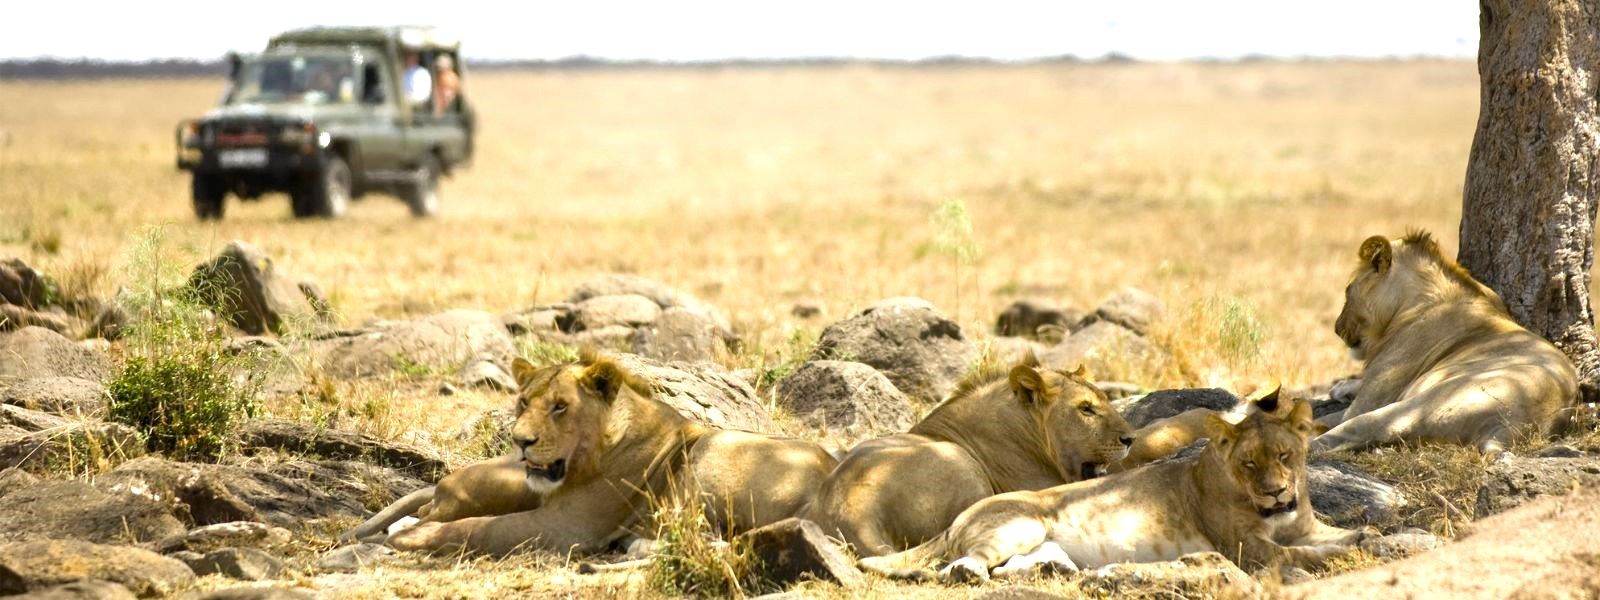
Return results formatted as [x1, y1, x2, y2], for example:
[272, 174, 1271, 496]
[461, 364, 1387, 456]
[0, 61, 1523, 597]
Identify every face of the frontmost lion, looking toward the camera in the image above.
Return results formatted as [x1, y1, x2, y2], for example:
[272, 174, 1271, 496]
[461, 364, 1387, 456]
[1218, 387, 1312, 518]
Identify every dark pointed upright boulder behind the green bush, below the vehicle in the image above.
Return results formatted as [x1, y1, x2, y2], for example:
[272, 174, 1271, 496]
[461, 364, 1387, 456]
[189, 240, 328, 336]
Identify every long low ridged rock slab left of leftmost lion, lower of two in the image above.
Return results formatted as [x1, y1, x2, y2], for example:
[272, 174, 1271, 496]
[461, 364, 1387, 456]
[96, 456, 426, 528]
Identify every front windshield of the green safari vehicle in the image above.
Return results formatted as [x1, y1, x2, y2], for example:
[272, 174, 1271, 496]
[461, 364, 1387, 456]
[227, 54, 355, 104]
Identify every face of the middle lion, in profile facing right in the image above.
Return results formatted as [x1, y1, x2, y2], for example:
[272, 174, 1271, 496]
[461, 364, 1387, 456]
[1011, 366, 1133, 478]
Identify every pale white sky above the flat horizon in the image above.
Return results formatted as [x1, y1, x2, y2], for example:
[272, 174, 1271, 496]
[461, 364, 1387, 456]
[0, 0, 1478, 61]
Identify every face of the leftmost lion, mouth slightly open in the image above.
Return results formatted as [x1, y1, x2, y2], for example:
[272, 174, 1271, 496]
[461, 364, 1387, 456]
[510, 358, 619, 493]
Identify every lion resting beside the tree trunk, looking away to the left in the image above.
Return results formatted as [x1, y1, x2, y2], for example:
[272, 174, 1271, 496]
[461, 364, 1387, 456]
[1312, 230, 1578, 453]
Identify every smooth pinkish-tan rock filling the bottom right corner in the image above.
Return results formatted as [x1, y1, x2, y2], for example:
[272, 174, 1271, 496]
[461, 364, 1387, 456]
[1278, 488, 1600, 600]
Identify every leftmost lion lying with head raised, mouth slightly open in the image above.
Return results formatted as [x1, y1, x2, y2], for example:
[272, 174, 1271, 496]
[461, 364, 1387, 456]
[387, 352, 837, 555]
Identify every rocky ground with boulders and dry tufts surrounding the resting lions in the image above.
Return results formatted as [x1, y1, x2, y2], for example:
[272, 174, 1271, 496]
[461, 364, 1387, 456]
[0, 242, 1600, 598]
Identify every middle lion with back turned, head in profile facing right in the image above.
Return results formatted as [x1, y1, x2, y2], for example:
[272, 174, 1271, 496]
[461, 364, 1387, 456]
[802, 354, 1133, 555]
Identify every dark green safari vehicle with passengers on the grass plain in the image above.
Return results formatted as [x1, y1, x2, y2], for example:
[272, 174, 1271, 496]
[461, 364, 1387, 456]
[178, 27, 475, 219]
